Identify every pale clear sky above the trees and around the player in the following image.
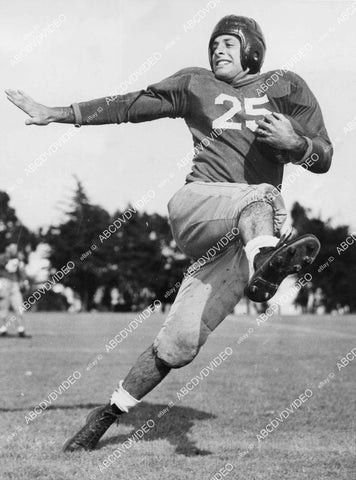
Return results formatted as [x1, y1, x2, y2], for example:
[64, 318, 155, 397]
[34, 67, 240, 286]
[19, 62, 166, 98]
[0, 0, 356, 231]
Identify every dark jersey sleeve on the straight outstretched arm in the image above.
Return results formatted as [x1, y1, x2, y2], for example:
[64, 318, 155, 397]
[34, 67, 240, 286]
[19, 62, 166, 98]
[76, 70, 192, 125]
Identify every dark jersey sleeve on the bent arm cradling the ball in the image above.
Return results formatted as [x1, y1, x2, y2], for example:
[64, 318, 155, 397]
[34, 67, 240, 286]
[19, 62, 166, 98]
[288, 73, 333, 166]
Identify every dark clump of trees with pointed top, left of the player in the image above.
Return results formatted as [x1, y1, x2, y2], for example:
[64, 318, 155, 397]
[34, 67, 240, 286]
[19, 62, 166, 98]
[45, 180, 192, 310]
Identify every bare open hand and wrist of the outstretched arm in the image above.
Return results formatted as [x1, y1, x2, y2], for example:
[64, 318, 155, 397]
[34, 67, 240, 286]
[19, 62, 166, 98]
[5, 89, 75, 125]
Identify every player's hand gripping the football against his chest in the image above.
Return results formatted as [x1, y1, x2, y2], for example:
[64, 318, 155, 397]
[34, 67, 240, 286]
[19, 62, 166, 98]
[255, 112, 300, 150]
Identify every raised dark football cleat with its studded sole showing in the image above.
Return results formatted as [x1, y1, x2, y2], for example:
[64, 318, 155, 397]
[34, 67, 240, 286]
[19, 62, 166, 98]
[245, 235, 320, 302]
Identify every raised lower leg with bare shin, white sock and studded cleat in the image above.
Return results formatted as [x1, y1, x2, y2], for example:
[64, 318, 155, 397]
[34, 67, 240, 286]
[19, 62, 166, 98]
[238, 202, 320, 302]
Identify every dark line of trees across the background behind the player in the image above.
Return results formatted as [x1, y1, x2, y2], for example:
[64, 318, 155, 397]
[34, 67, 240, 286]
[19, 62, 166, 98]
[0, 180, 356, 312]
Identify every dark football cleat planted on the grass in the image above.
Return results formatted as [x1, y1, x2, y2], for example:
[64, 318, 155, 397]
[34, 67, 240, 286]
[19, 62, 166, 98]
[63, 403, 123, 452]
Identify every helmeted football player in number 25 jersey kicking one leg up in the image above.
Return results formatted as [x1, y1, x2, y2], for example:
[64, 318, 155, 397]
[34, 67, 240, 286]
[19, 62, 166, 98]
[6, 15, 332, 451]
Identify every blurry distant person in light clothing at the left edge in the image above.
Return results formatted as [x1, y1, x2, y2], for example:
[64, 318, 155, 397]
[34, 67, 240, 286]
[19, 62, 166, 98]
[0, 243, 28, 338]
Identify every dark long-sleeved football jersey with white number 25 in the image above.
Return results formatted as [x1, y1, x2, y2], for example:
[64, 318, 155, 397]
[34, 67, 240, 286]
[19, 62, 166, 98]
[79, 68, 332, 186]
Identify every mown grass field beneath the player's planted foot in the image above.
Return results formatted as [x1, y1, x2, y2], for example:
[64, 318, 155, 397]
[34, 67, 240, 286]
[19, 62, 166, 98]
[0, 314, 356, 480]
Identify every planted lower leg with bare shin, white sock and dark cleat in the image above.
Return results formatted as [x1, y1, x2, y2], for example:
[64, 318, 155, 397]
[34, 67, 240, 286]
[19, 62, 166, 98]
[63, 345, 170, 452]
